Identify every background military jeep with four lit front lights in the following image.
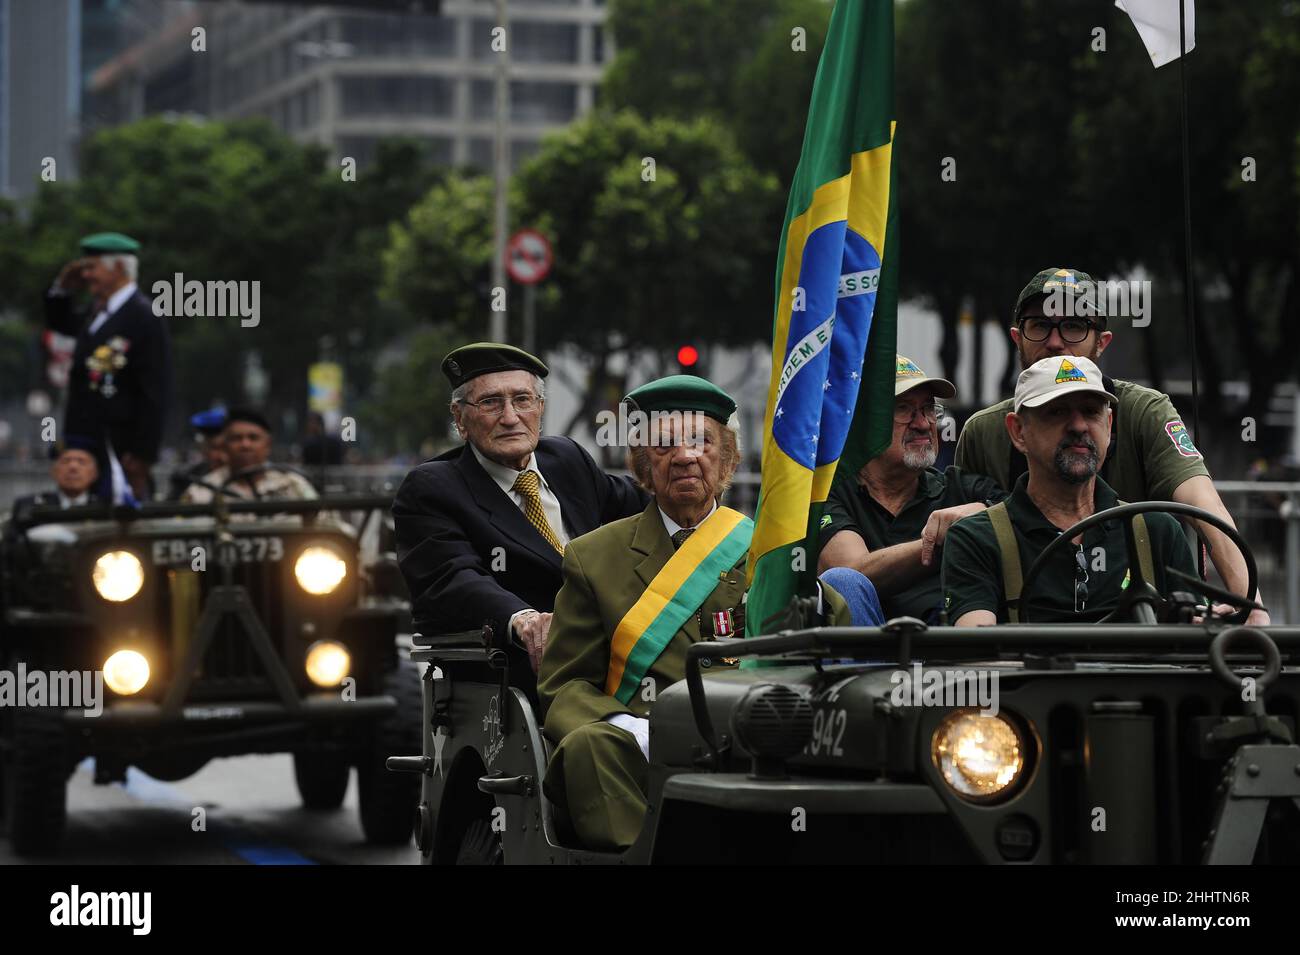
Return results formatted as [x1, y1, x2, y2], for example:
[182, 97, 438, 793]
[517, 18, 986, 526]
[0, 475, 420, 854]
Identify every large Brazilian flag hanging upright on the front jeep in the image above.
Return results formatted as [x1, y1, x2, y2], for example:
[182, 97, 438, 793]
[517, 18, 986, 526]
[745, 0, 898, 637]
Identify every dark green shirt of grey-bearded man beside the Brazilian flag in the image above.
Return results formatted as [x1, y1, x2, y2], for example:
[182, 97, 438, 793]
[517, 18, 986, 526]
[822, 466, 1006, 620]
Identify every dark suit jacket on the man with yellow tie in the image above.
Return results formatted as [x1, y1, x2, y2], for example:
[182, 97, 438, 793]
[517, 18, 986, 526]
[393, 438, 649, 639]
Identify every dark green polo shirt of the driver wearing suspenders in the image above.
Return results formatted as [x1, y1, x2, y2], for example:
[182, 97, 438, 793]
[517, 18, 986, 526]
[943, 474, 1196, 624]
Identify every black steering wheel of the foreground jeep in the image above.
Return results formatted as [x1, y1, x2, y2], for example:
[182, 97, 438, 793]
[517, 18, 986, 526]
[1021, 500, 1260, 624]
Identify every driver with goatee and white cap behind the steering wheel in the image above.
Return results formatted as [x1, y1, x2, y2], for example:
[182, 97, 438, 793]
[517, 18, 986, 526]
[943, 356, 1196, 626]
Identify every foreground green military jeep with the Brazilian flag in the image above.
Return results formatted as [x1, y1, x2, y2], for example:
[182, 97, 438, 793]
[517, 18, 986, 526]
[389, 504, 1300, 864]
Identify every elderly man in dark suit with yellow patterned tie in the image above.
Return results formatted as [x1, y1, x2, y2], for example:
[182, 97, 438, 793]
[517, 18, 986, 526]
[393, 342, 645, 670]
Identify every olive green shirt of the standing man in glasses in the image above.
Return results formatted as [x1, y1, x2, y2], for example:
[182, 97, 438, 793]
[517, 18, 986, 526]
[956, 379, 1209, 502]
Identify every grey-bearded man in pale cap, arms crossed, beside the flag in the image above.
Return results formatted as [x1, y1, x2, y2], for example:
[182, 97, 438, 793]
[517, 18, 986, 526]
[818, 355, 1006, 624]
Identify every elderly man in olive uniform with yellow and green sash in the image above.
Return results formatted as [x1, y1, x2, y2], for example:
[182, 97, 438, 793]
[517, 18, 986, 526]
[537, 376, 866, 851]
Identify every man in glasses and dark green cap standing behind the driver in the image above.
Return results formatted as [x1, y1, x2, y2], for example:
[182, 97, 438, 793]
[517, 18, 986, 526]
[956, 269, 1269, 626]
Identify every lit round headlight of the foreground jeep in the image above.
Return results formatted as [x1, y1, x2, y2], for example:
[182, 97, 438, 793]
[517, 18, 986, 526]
[931, 709, 1024, 802]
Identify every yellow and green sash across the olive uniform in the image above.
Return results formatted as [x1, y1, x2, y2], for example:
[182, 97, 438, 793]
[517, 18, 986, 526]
[605, 507, 754, 704]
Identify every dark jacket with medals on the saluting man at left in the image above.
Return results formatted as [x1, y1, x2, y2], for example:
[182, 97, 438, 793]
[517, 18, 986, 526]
[46, 283, 172, 462]
